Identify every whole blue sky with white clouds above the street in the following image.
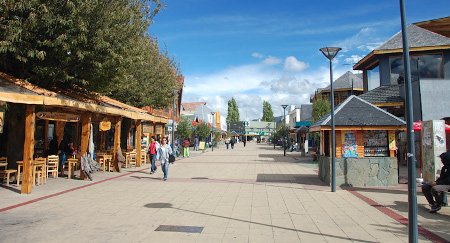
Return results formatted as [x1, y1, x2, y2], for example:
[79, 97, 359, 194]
[149, 0, 450, 120]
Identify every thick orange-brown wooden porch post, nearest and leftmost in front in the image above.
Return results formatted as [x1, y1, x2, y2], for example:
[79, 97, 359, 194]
[21, 105, 36, 194]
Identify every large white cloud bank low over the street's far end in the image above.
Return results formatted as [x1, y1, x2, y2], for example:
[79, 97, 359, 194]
[183, 58, 351, 120]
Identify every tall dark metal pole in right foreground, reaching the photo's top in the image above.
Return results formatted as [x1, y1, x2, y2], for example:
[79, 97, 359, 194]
[400, 0, 418, 242]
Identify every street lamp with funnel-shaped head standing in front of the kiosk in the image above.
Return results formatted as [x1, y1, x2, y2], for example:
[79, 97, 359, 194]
[320, 47, 342, 192]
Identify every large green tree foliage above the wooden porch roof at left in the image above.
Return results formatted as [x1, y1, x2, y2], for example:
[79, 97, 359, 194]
[0, 0, 178, 107]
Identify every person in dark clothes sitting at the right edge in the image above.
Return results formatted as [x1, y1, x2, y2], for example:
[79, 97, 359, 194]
[422, 152, 450, 213]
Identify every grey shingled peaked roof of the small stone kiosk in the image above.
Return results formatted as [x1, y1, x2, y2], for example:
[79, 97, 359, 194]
[311, 95, 405, 127]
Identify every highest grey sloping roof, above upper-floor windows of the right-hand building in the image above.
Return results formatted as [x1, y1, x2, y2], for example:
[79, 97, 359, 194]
[375, 24, 450, 50]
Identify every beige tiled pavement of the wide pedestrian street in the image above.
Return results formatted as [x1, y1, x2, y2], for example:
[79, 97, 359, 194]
[0, 142, 450, 243]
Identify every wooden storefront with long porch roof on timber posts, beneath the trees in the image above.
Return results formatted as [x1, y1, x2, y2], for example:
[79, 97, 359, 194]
[0, 73, 161, 194]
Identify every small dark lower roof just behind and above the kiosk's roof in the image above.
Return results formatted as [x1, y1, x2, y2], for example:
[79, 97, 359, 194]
[358, 85, 403, 104]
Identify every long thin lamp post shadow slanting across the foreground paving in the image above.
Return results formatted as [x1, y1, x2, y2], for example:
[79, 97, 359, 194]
[144, 203, 375, 243]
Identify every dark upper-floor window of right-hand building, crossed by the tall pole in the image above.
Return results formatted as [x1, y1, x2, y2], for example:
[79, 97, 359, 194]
[389, 54, 444, 84]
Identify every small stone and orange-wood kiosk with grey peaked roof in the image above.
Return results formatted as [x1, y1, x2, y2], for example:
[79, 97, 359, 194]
[310, 96, 405, 186]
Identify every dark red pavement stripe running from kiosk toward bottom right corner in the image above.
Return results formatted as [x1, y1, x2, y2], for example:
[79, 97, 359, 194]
[347, 189, 449, 243]
